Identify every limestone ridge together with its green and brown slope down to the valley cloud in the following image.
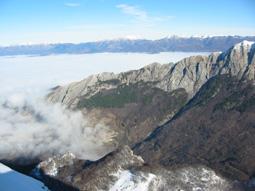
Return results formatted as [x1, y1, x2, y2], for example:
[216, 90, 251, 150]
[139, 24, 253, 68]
[47, 41, 255, 154]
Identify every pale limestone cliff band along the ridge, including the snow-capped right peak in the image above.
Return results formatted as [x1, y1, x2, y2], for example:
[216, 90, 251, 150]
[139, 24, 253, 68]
[48, 41, 255, 108]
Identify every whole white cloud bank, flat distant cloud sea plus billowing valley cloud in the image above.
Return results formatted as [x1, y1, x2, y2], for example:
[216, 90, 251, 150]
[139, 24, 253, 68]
[0, 53, 209, 164]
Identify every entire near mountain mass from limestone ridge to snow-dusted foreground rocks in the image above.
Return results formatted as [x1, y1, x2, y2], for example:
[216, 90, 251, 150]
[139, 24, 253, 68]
[27, 41, 255, 191]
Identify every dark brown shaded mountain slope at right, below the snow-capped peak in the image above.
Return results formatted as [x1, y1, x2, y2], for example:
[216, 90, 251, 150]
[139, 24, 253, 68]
[134, 75, 255, 180]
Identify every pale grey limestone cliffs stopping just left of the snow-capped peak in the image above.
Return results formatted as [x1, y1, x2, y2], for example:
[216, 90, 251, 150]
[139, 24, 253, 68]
[48, 56, 213, 108]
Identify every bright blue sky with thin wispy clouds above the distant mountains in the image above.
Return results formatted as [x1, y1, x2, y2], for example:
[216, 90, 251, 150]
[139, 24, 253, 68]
[0, 0, 255, 45]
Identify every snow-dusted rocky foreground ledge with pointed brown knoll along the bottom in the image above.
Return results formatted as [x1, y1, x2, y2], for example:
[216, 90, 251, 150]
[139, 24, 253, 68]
[32, 146, 240, 191]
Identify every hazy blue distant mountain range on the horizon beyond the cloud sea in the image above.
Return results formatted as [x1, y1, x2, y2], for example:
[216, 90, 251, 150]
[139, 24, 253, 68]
[0, 36, 255, 56]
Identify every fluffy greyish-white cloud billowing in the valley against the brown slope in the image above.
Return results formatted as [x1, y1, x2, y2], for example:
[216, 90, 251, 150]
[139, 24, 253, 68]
[0, 94, 114, 164]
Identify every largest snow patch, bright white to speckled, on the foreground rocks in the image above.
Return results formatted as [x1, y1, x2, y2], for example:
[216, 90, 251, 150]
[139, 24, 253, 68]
[107, 166, 232, 191]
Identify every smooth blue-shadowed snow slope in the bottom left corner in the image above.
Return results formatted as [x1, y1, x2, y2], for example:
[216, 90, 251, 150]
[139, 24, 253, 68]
[0, 163, 49, 191]
